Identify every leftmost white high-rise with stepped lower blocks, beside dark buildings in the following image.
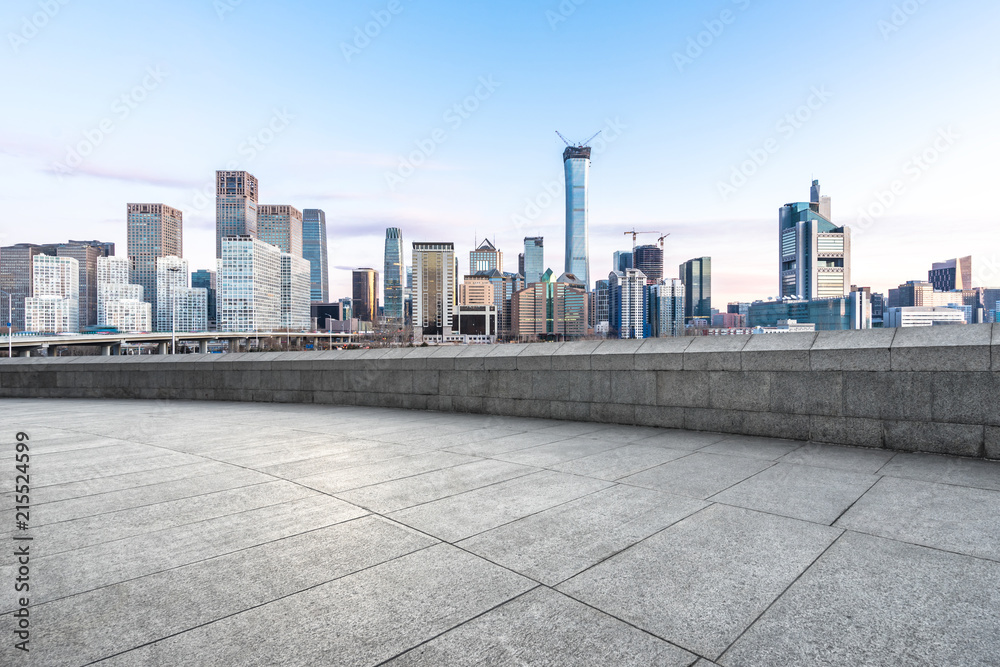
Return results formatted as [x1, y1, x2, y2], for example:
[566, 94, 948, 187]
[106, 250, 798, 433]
[24, 255, 80, 333]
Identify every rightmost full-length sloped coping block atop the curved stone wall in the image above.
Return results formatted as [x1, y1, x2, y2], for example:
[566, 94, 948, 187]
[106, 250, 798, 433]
[891, 324, 993, 371]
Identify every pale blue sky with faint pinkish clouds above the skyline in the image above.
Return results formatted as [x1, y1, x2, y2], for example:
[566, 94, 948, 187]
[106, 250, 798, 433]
[0, 0, 1000, 307]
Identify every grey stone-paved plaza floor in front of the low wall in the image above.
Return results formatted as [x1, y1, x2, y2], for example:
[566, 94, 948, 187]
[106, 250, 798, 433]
[0, 399, 1000, 667]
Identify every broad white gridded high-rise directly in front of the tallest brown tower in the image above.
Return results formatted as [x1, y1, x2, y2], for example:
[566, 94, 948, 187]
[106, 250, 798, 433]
[218, 236, 281, 332]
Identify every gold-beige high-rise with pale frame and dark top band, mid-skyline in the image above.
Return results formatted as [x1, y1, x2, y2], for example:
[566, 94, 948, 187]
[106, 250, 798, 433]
[413, 242, 457, 342]
